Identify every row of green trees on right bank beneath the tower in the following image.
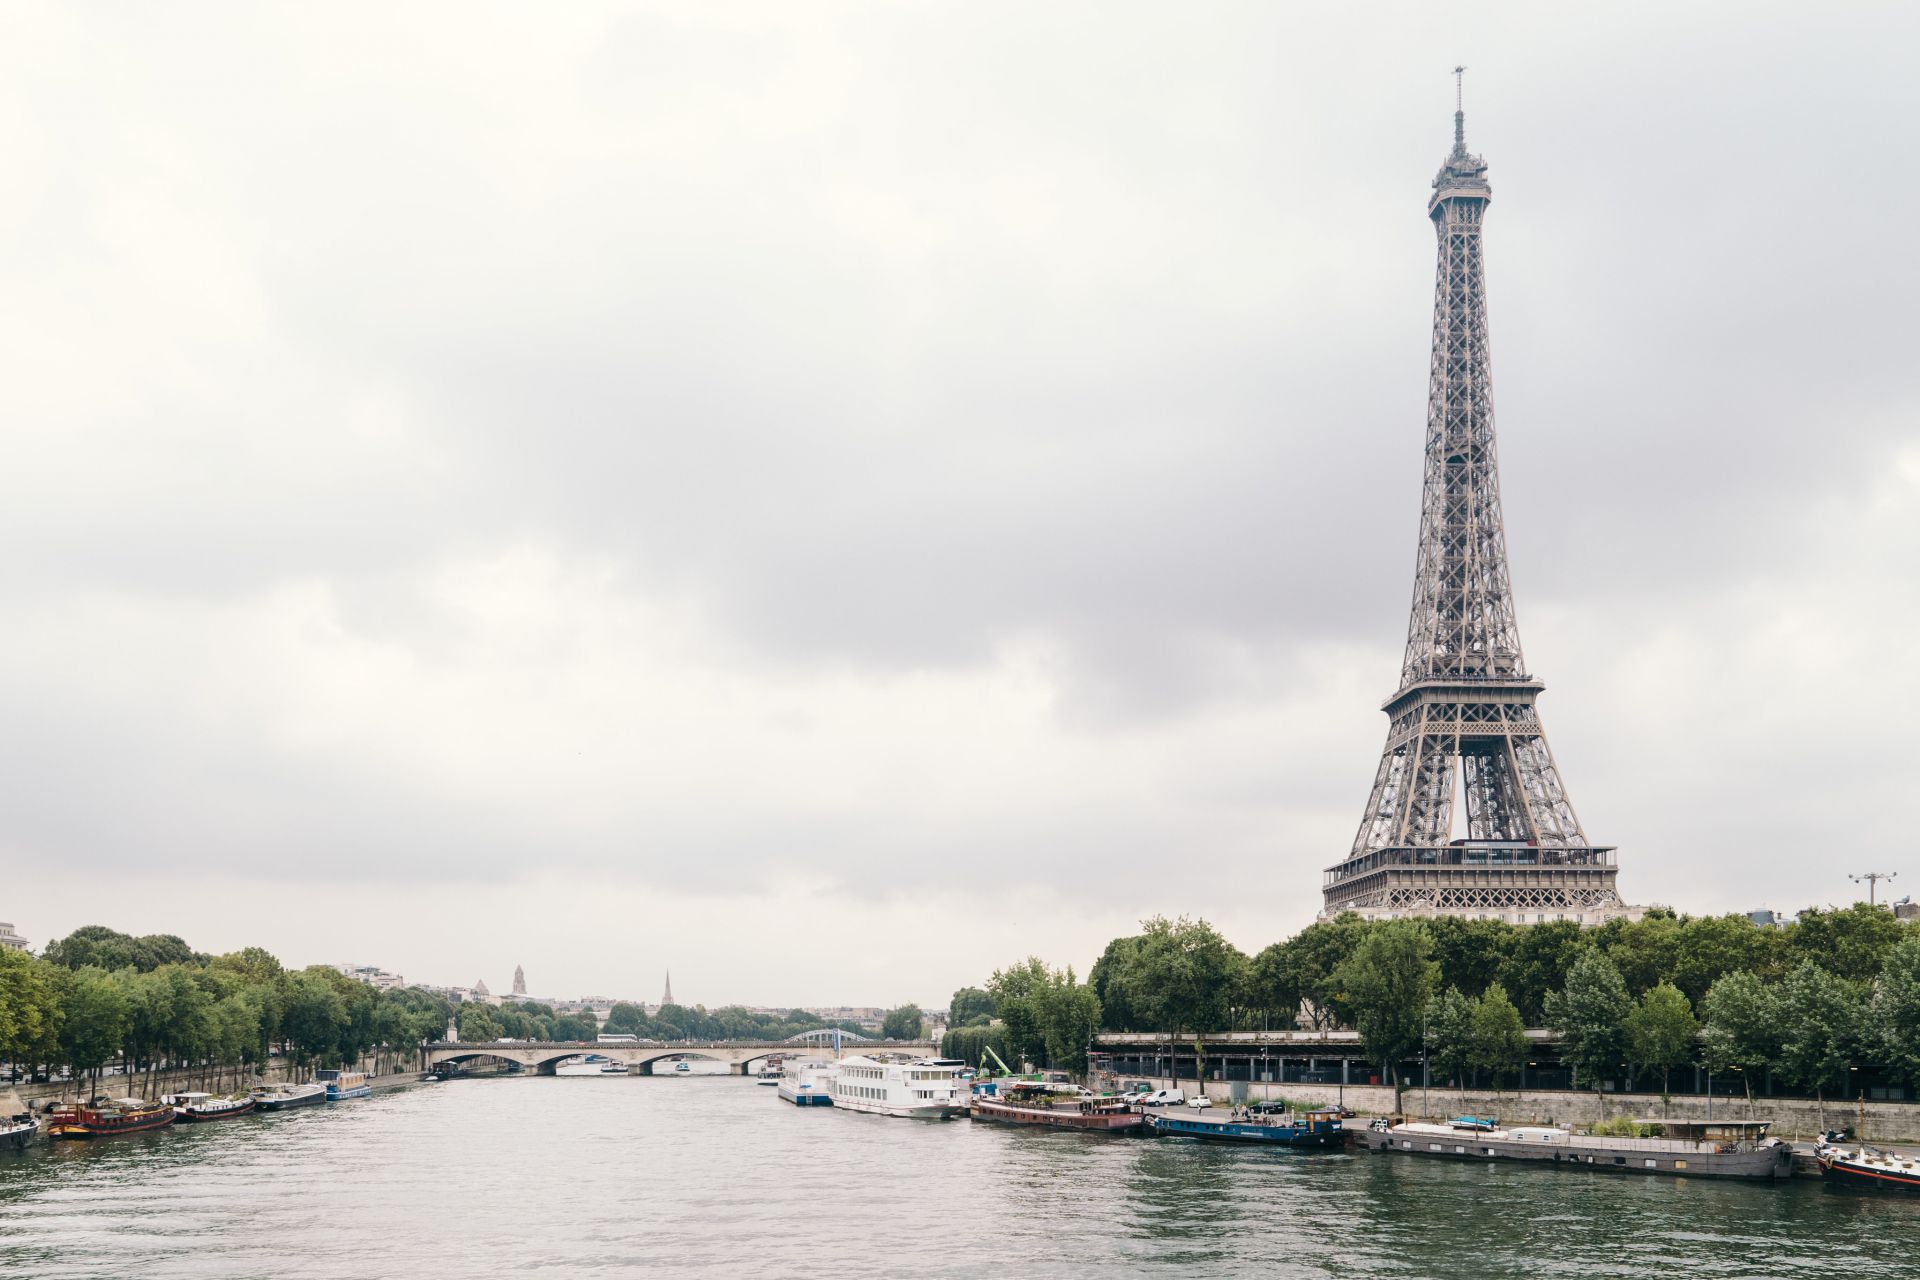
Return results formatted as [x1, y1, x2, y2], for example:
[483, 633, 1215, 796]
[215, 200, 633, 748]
[943, 904, 1920, 1098]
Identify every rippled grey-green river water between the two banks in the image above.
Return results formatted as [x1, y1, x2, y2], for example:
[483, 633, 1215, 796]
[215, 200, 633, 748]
[0, 1077, 1920, 1280]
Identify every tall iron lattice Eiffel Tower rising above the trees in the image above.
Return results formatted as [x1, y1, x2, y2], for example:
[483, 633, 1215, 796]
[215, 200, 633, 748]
[1323, 67, 1634, 923]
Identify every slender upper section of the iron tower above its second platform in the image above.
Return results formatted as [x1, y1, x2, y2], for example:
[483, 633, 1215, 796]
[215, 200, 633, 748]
[1400, 75, 1526, 691]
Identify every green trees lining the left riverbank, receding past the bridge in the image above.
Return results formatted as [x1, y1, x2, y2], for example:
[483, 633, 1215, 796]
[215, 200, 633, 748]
[0, 925, 879, 1094]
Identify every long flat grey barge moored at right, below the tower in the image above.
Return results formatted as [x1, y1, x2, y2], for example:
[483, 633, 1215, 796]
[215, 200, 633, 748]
[1359, 1119, 1793, 1180]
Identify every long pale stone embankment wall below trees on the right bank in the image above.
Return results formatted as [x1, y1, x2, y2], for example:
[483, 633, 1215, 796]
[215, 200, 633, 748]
[1127, 1077, 1920, 1142]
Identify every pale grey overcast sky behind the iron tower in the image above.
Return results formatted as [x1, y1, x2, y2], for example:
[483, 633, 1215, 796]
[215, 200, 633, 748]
[0, 0, 1920, 1006]
